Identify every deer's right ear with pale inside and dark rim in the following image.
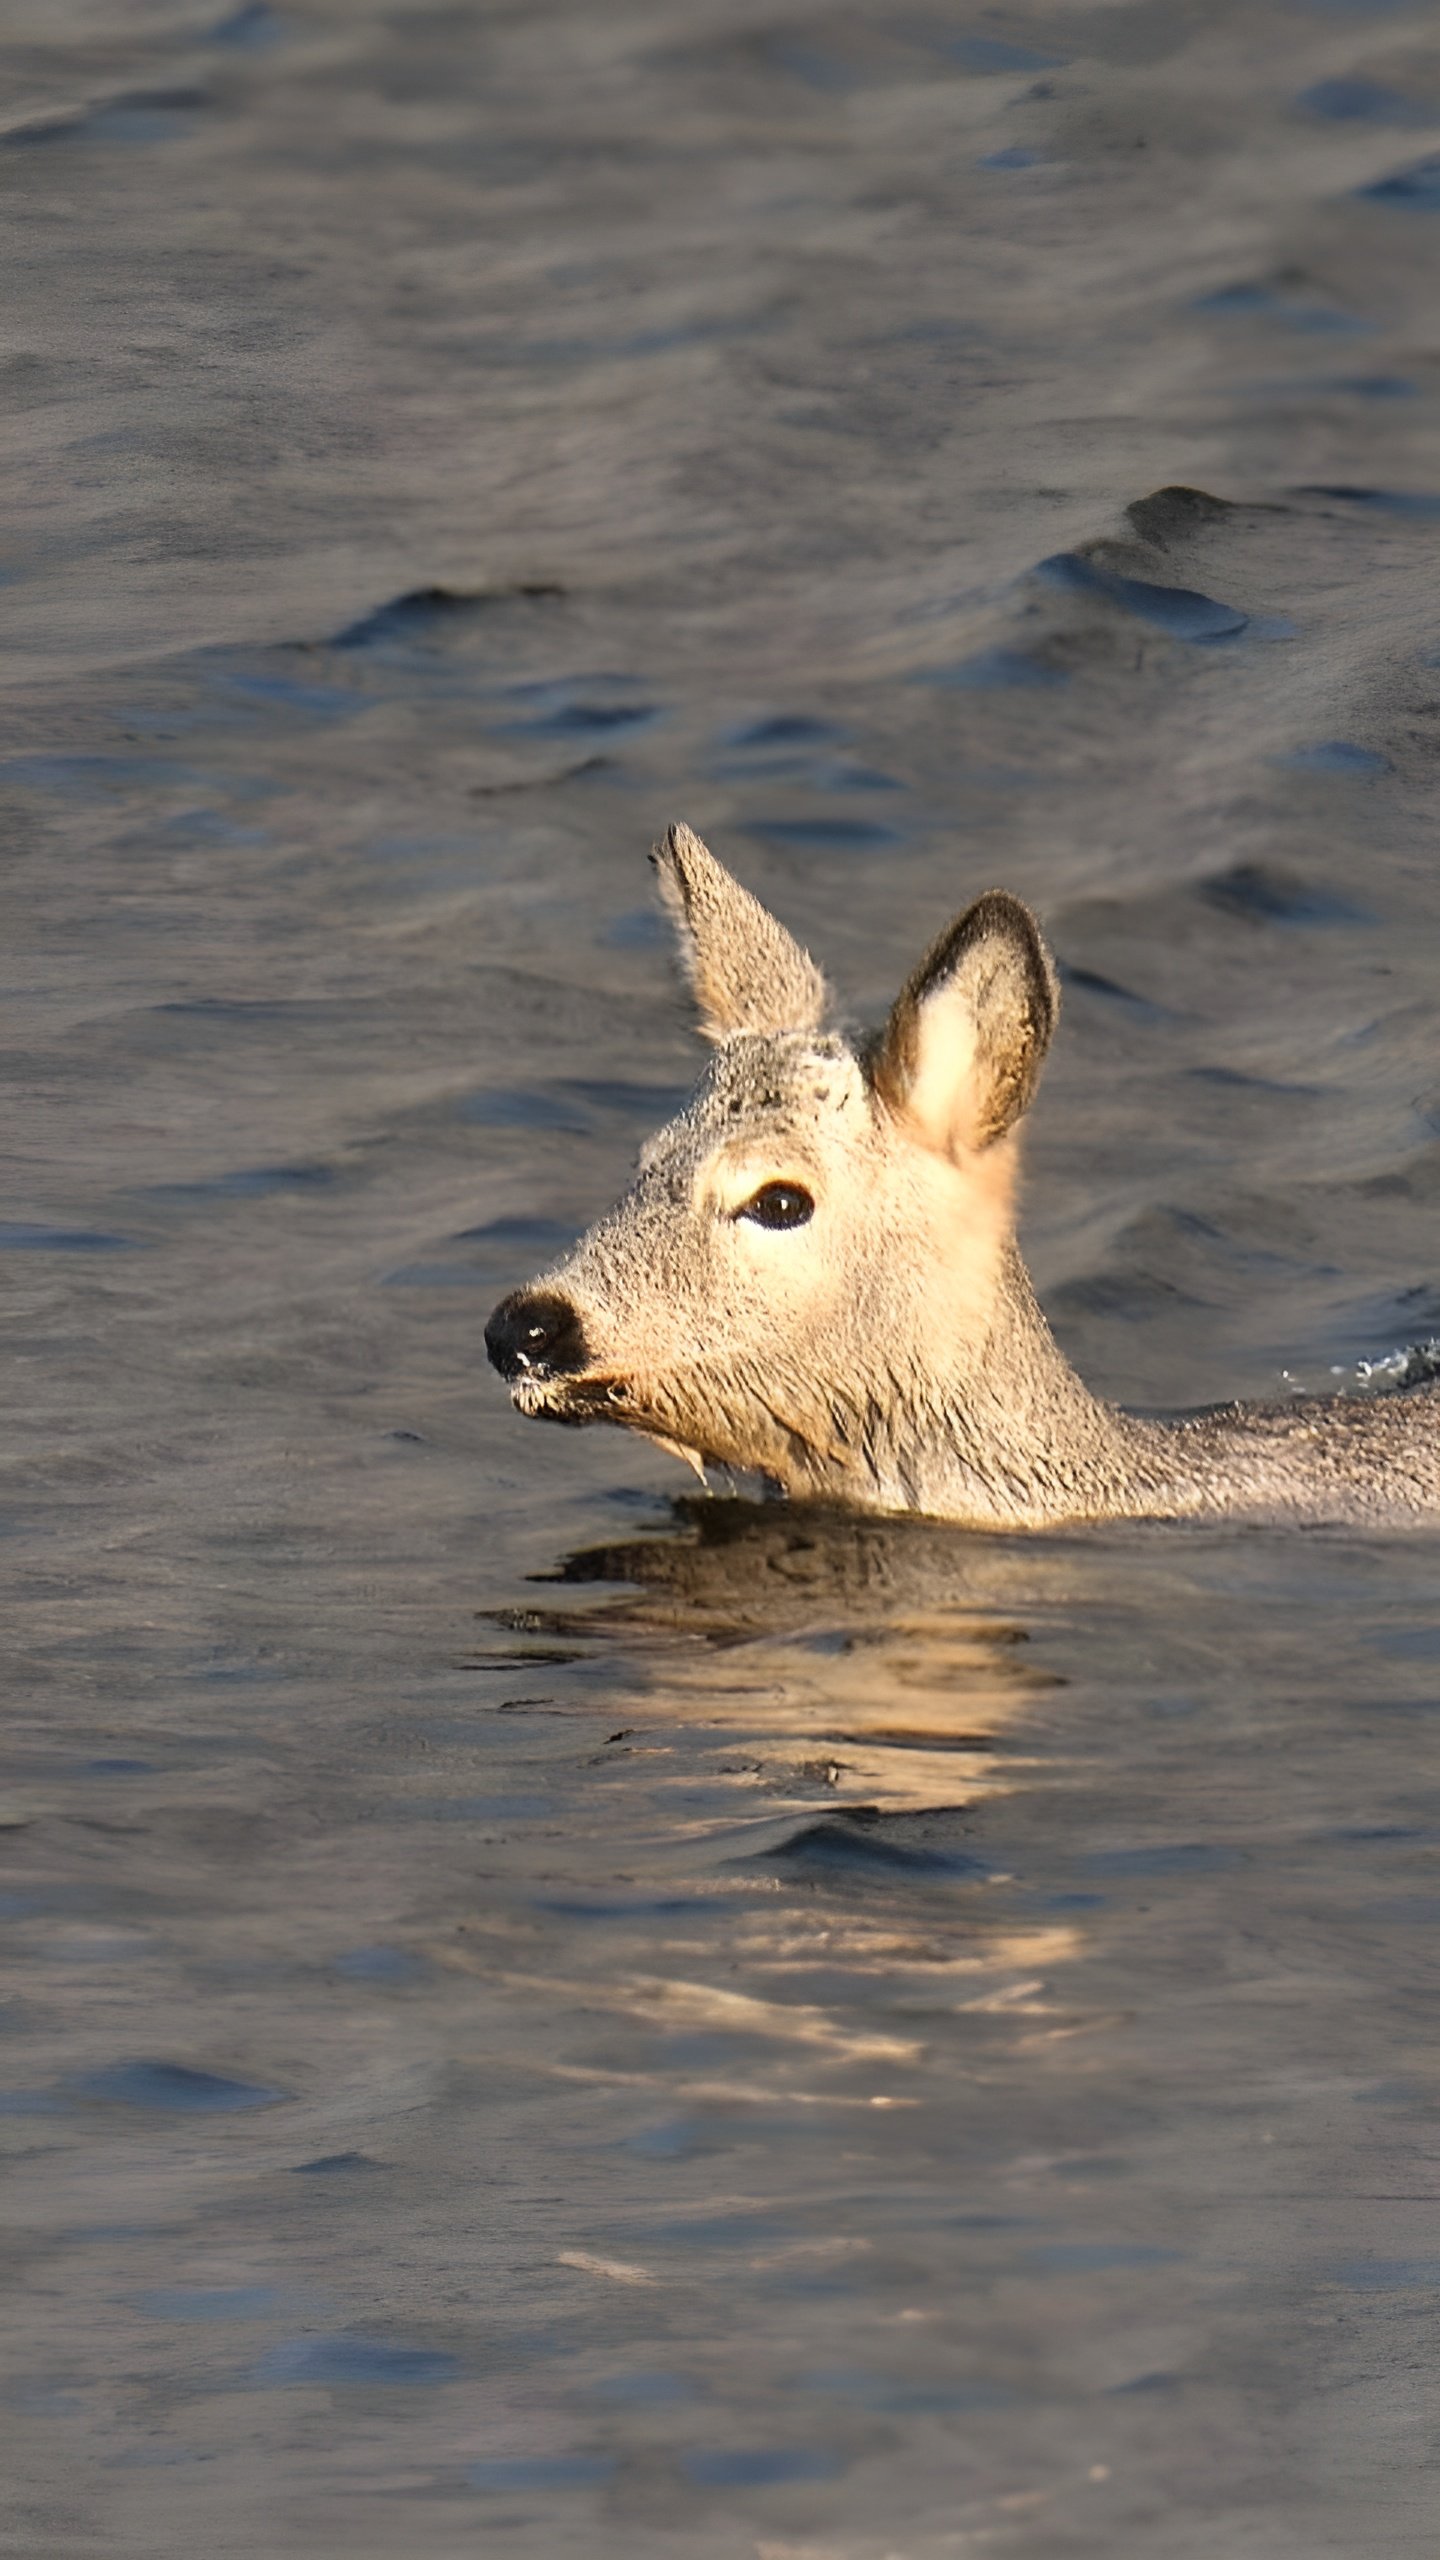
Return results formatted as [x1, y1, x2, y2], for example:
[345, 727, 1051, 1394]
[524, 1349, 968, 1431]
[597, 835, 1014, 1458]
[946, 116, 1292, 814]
[871, 888, 1061, 1155]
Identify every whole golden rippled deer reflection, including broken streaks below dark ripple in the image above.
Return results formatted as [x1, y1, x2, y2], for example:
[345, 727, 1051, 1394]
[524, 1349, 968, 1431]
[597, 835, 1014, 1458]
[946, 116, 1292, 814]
[461, 1498, 1081, 2107]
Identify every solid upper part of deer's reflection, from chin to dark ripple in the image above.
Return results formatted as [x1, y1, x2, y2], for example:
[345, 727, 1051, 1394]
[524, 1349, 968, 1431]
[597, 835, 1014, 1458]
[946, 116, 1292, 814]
[491, 1498, 1063, 1823]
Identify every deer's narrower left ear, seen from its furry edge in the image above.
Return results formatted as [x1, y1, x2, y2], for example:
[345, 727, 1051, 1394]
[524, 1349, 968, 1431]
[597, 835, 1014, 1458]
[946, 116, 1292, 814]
[651, 827, 830, 1039]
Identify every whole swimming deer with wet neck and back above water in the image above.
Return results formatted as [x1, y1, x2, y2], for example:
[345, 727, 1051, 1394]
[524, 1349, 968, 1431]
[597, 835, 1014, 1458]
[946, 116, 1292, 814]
[484, 827, 1440, 1528]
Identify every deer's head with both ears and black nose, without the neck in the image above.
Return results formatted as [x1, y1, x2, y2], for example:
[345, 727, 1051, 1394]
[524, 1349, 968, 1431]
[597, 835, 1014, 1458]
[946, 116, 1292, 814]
[484, 827, 1058, 1510]
